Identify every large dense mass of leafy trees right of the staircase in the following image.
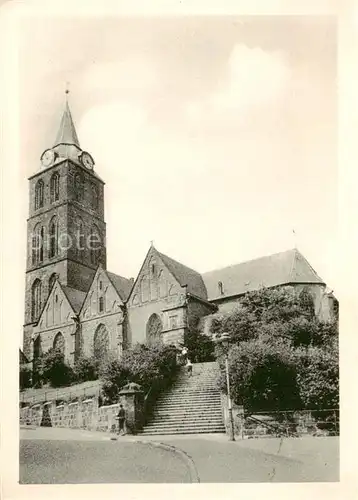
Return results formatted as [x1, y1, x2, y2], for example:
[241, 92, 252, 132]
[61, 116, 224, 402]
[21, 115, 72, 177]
[212, 287, 339, 411]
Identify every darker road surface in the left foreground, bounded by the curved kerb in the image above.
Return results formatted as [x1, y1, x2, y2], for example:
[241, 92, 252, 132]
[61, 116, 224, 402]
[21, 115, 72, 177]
[20, 438, 191, 484]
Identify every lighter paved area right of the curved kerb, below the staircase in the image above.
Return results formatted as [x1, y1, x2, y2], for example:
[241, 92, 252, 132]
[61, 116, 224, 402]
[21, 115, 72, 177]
[161, 436, 339, 483]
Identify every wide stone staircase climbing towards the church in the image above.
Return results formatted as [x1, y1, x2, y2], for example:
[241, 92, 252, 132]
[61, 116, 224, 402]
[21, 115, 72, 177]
[142, 362, 225, 434]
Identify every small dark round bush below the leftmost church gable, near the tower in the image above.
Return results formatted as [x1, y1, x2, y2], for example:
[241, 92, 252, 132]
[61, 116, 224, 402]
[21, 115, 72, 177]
[36, 348, 74, 387]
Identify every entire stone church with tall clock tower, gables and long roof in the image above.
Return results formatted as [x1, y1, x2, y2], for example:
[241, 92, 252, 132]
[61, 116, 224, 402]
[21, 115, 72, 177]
[23, 102, 335, 364]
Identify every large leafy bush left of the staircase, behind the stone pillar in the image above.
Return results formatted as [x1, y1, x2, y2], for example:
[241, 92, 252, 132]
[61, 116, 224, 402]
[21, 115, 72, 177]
[101, 344, 177, 402]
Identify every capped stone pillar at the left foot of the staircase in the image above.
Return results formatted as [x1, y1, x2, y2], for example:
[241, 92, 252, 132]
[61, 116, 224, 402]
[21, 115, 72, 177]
[119, 383, 144, 434]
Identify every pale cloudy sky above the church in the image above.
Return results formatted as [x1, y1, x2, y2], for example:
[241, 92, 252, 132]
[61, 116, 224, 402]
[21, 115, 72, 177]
[14, 16, 337, 334]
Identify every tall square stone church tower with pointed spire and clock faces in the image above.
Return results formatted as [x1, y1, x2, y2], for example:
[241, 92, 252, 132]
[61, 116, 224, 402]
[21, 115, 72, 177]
[23, 96, 106, 356]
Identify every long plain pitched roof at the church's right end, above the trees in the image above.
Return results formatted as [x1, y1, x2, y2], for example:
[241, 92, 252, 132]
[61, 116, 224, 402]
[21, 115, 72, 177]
[202, 249, 324, 300]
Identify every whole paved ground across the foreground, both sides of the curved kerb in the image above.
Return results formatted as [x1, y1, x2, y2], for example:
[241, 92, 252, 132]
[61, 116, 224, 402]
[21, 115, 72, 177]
[20, 428, 339, 483]
